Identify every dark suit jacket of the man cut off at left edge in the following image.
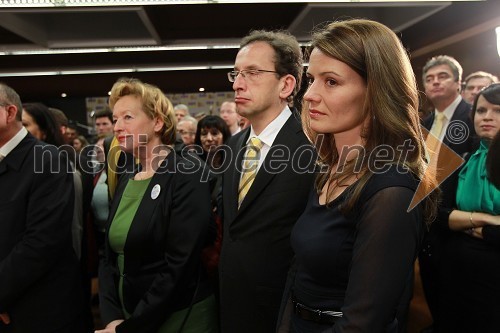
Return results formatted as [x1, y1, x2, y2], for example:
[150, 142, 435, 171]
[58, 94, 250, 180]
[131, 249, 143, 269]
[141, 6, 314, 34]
[0, 134, 83, 333]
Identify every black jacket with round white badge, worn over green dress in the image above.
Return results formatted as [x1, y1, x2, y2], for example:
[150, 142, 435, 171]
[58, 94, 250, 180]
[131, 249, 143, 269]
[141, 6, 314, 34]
[99, 152, 211, 333]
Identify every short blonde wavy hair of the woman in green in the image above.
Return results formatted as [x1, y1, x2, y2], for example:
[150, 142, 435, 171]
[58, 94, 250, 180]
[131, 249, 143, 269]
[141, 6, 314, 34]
[109, 78, 176, 145]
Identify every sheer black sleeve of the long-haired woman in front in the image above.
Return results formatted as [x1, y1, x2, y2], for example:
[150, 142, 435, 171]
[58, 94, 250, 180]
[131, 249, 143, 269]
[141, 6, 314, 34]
[329, 187, 424, 333]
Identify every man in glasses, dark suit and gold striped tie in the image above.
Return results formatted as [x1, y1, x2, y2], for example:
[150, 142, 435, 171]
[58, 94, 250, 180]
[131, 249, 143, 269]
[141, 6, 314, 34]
[219, 31, 314, 333]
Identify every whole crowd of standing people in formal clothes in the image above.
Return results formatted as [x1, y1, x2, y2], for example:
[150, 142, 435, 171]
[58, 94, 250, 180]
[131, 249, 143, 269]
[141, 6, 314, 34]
[0, 19, 500, 333]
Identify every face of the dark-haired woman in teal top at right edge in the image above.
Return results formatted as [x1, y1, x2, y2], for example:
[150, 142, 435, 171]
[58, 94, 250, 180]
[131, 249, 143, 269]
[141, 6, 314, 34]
[474, 96, 500, 140]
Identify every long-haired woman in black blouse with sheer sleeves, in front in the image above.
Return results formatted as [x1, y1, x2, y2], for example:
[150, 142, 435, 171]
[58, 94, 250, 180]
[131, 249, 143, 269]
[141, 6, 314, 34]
[278, 20, 436, 333]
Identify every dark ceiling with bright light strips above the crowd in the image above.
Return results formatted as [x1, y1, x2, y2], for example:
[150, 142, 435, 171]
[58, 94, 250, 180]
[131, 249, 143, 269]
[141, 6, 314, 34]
[0, 0, 500, 100]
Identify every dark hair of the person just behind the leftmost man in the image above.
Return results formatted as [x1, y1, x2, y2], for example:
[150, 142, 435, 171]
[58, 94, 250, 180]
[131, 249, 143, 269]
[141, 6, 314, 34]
[23, 103, 64, 147]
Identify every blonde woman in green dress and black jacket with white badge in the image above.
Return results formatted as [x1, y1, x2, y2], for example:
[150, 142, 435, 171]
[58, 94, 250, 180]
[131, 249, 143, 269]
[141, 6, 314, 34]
[96, 79, 217, 333]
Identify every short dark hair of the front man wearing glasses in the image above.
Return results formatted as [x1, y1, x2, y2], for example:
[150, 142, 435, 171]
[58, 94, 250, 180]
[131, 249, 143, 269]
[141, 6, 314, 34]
[240, 30, 303, 102]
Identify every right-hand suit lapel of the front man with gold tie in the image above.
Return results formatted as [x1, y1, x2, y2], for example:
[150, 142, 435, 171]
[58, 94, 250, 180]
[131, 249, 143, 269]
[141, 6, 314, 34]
[236, 114, 300, 214]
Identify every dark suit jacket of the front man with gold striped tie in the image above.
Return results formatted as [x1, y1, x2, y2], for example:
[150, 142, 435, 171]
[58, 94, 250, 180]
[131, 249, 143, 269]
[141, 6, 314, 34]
[219, 115, 316, 333]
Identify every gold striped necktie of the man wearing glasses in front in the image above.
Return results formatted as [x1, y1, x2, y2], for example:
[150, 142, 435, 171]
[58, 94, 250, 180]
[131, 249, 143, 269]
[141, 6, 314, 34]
[238, 137, 264, 208]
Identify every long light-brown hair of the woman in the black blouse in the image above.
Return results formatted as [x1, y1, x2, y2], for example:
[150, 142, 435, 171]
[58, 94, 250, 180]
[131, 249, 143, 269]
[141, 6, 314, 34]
[302, 19, 436, 221]
